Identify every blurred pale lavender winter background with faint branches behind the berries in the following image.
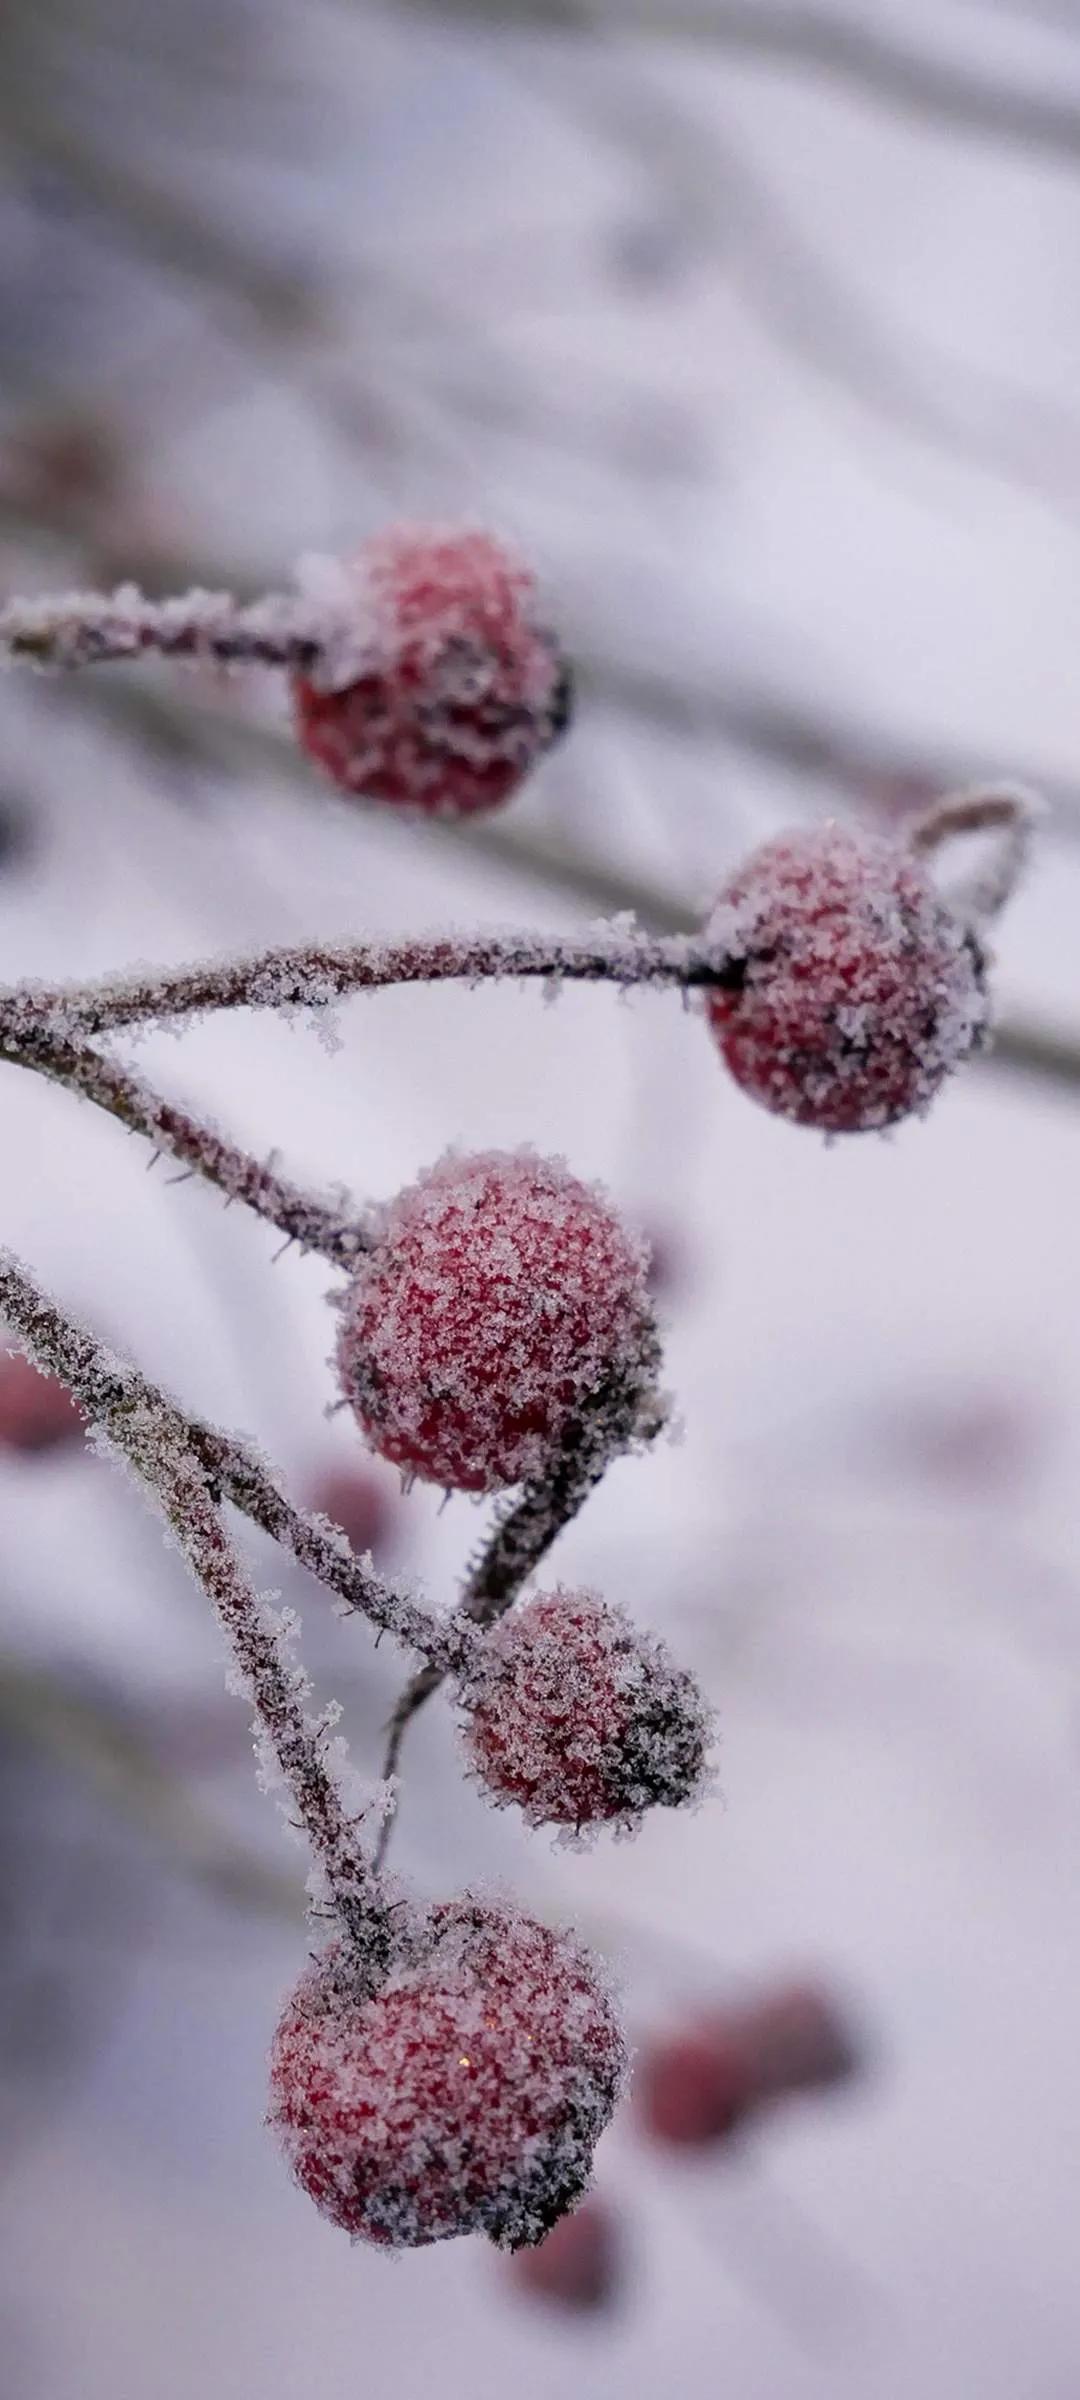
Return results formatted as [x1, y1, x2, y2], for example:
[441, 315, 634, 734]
[0, 0, 1080, 2400]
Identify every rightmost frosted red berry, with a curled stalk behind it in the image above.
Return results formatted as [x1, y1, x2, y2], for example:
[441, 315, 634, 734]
[706, 826, 989, 1133]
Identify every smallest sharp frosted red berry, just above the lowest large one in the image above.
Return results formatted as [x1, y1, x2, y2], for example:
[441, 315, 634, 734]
[461, 1591, 710, 1826]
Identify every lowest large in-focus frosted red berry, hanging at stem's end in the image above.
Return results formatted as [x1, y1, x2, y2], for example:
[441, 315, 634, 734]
[269, 1898, 626, 2249]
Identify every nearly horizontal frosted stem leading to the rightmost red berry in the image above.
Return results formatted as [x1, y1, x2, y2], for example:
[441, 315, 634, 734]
[14, 919, 739, 1034]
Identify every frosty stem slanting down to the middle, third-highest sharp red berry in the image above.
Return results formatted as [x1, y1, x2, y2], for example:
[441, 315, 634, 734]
[0, 994, 370, 1270]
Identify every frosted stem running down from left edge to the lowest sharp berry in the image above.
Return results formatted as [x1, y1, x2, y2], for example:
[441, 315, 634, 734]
[0, 1253, 391, 1958]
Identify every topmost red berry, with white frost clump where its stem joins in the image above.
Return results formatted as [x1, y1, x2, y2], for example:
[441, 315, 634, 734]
[293, 526, 571, 816]
